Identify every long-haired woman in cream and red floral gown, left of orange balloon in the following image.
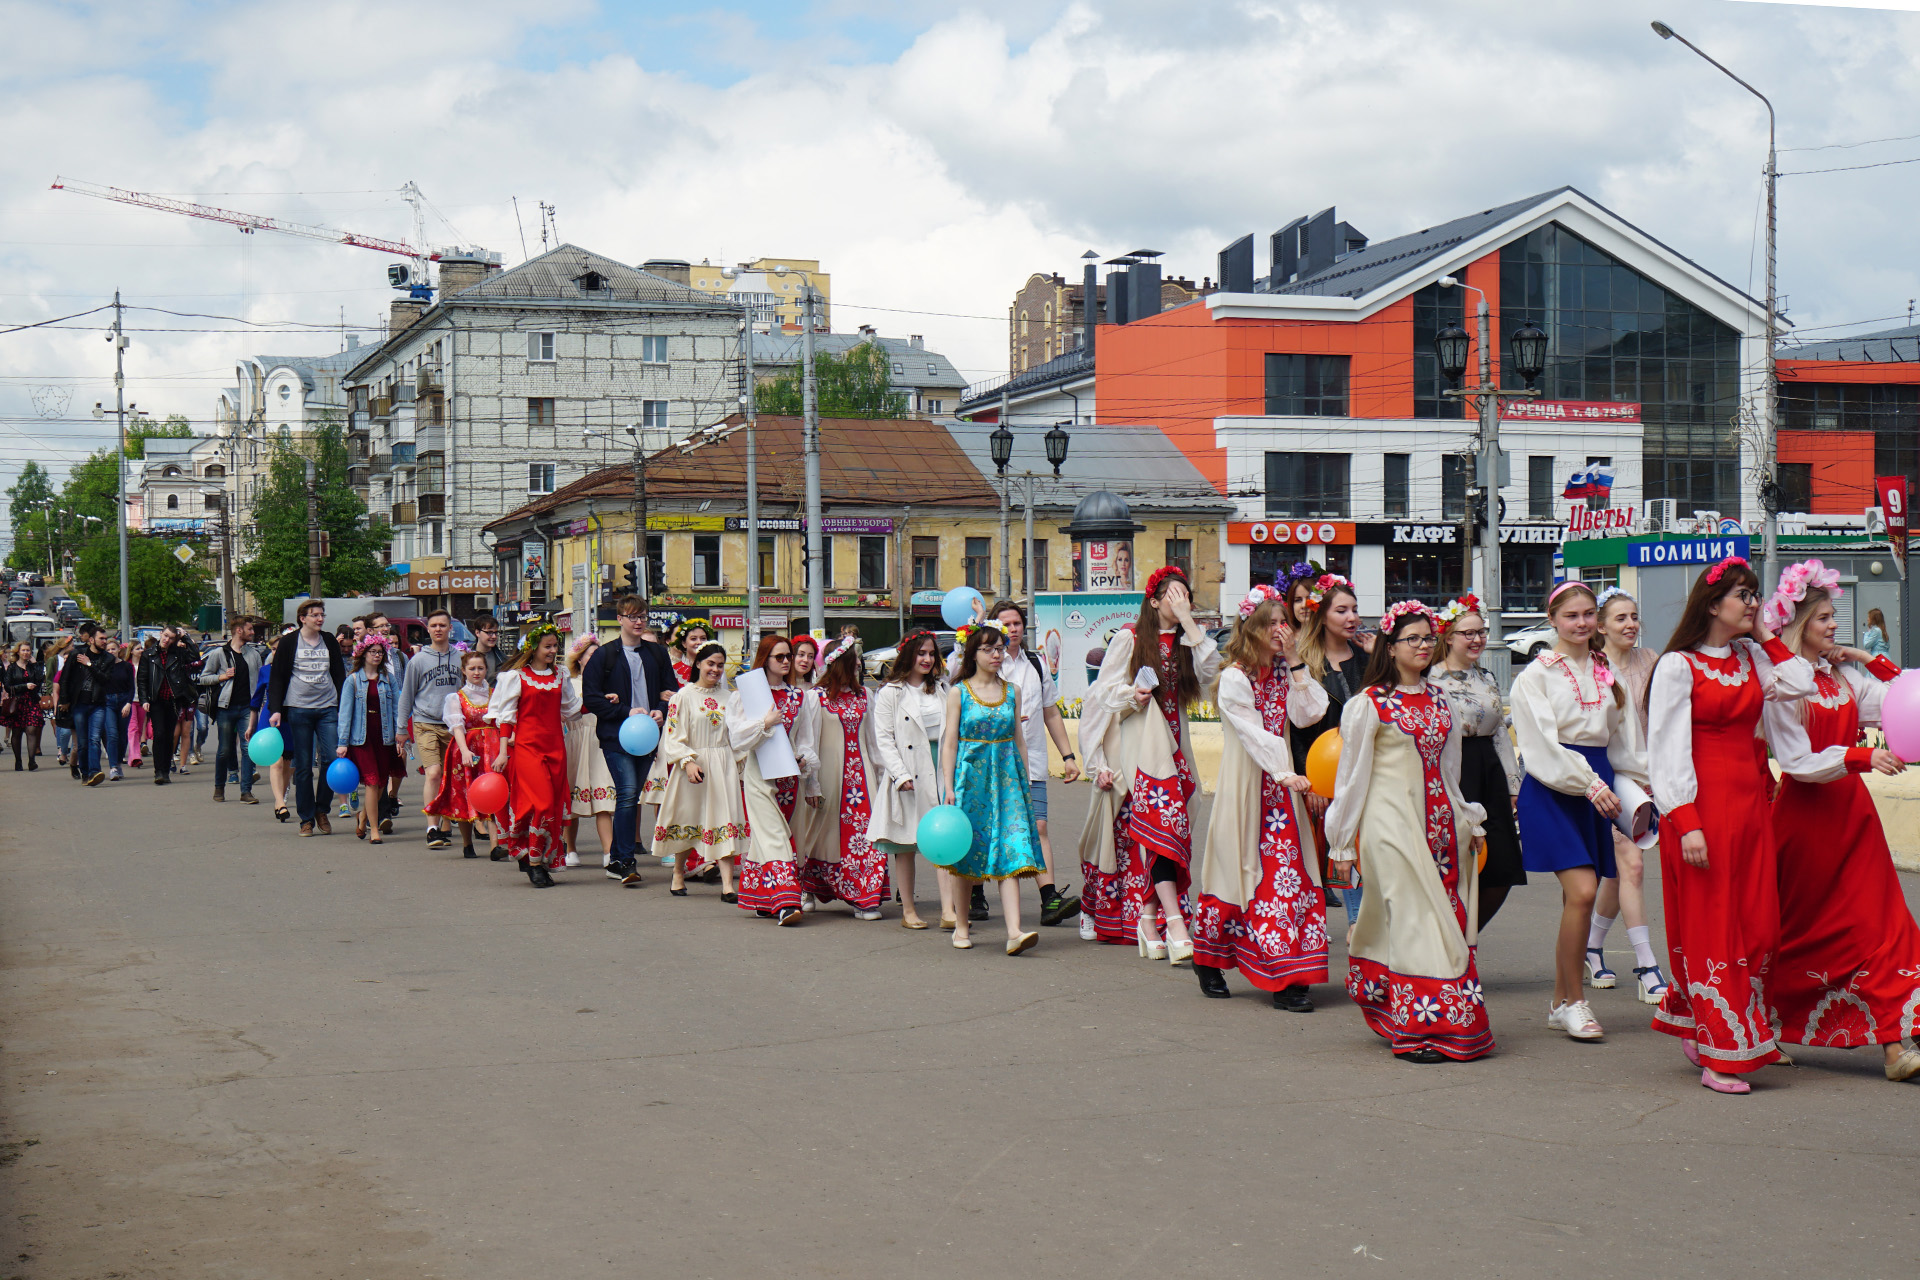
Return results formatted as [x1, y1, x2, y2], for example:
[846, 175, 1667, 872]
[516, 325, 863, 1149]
[1194, 585, 1327, 1013]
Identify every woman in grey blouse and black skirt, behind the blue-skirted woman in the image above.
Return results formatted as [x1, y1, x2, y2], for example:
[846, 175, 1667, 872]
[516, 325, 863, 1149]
[1428, 595, 1526, 929]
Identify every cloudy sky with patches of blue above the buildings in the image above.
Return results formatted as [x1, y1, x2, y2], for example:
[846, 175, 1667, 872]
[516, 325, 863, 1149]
[0, 0, 1920, 510]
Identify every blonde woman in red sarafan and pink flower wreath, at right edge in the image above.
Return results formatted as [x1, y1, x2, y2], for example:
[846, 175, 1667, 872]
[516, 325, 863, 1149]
[1764, 560, 1920, 1080]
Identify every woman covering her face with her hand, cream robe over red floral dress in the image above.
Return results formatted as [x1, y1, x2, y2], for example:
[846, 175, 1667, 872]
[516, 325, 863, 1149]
[1081, 566, 1219, 965]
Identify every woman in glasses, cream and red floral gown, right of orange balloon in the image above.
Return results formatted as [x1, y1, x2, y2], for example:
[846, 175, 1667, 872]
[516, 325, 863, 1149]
[1327, 601, 1494, 1063]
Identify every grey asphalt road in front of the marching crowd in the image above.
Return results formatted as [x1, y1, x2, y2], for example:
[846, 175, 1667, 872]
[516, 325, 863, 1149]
[0, 770, 1920, 1280]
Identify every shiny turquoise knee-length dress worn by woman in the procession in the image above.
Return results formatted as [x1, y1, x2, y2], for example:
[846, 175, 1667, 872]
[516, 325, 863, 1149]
[947, 685, 1046, 881]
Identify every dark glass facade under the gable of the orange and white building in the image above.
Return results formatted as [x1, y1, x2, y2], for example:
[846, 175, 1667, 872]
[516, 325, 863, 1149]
[1489, 225, 1741, 516]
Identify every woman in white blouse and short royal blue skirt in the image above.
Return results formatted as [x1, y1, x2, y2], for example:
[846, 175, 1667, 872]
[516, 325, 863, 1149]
[1511, 581, 1647, 1040]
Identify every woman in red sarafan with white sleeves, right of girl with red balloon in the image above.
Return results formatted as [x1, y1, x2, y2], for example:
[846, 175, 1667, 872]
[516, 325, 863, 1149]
[486, 626, 580, 889]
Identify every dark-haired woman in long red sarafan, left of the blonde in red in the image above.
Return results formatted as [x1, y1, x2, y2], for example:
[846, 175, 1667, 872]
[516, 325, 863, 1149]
[1647, 557, 1814, 1094]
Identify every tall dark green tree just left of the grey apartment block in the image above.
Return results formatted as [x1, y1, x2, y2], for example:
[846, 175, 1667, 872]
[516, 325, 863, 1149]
[234, 416, 394, 612]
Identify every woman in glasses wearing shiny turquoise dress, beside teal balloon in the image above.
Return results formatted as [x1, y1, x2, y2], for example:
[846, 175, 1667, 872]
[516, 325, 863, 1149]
[939, 622, 1046, 956]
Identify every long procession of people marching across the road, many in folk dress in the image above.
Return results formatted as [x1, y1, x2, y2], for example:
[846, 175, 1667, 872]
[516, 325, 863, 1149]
[11, 558, 1920, 1094]
